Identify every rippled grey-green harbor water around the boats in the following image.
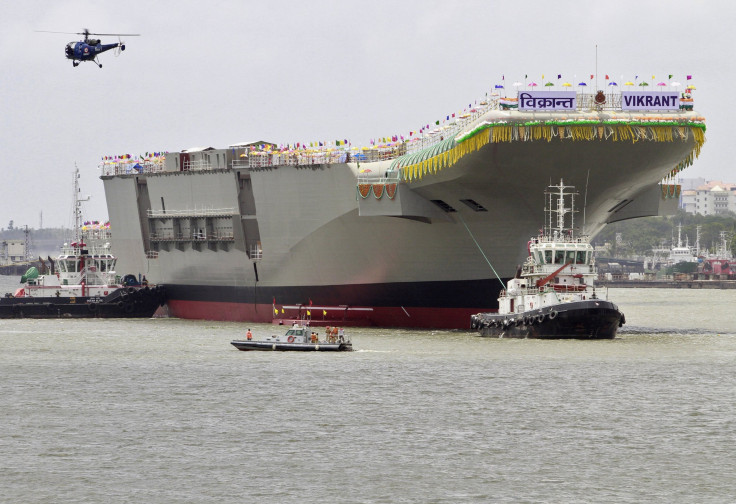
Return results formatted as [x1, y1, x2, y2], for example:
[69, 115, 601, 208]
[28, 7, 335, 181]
[0, 277, 736, 504]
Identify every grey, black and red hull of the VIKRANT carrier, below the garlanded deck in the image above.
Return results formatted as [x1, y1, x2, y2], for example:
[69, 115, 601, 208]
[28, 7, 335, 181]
[102, 112, 695, 329]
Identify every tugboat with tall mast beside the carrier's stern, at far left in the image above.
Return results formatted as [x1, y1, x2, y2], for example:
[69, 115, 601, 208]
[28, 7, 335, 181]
[0, 170, 165, 318]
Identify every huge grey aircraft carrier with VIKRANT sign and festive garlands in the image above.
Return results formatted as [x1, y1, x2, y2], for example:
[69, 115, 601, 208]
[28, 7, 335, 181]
[101, 88, 705, 329]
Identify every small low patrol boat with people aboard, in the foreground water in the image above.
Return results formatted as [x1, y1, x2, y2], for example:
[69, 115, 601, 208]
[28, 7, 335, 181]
[230, 324, 353, 352]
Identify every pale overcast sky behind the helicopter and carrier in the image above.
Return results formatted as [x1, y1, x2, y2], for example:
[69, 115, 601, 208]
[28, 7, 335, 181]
[0, 0, 736, 228]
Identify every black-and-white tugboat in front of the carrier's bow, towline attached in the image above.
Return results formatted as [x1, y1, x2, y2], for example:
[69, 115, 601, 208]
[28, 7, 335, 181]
[470, 180, 626, 339]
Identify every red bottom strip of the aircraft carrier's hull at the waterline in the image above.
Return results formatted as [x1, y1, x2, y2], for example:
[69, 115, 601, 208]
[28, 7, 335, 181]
[167, 300, 488, 330]
